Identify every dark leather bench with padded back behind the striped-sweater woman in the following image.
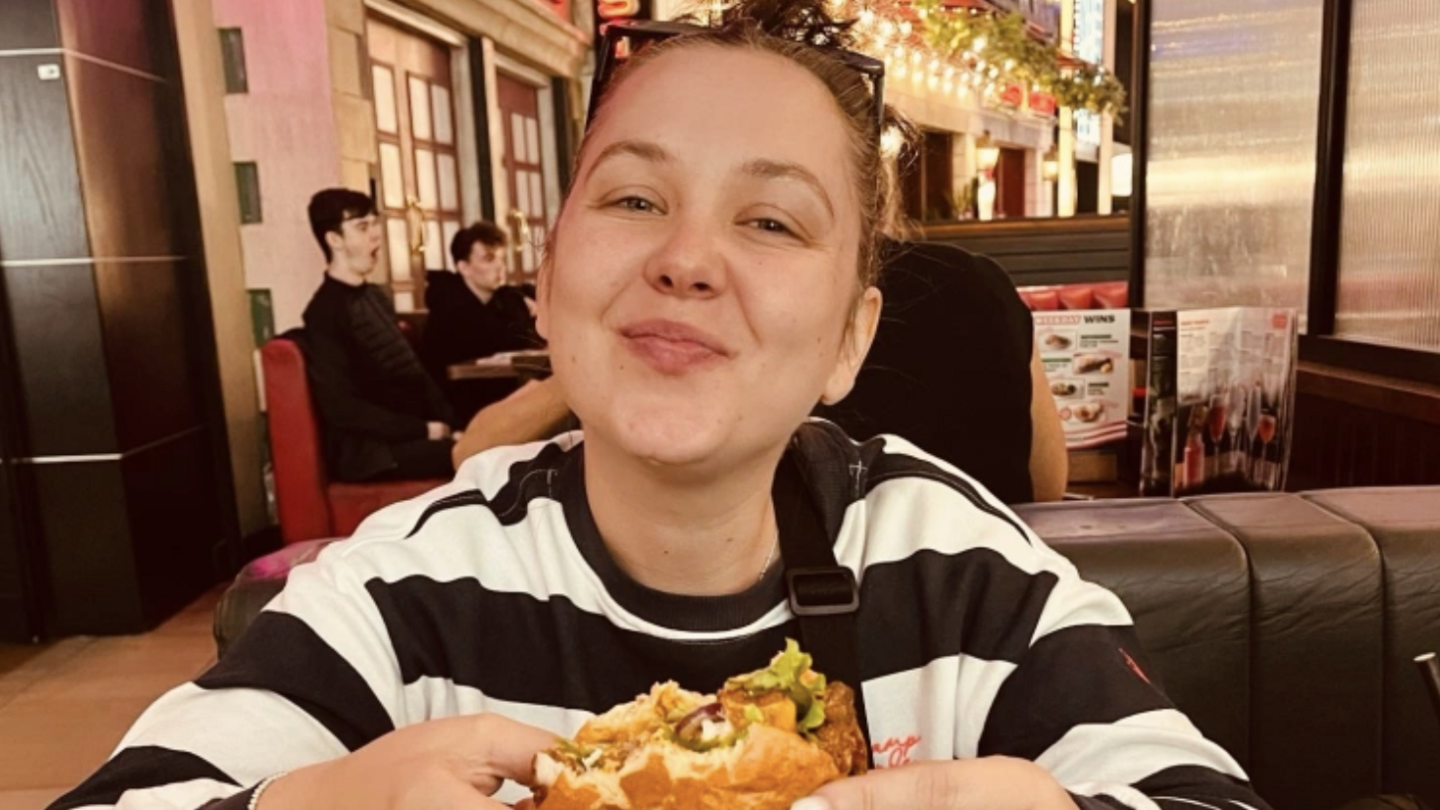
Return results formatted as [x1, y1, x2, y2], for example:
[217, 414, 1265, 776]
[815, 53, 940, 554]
[216, 487, 1440, 810]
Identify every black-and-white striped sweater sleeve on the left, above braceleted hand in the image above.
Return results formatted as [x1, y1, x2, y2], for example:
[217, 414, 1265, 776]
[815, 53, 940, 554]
[50, 533, 408, 810]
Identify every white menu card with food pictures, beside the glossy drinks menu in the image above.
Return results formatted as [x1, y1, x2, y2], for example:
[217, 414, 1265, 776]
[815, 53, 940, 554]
[1034, 310, 1130, 450]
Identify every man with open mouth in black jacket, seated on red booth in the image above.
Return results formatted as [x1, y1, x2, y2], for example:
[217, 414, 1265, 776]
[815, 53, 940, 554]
[305, 189, 454, 481]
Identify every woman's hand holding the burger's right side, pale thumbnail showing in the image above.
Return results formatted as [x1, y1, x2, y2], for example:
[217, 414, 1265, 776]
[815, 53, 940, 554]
[792, 757, 1076, 810]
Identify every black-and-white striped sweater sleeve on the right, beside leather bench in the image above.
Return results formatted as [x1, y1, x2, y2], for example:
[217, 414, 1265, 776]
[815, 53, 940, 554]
[978, 524, 1267, 810]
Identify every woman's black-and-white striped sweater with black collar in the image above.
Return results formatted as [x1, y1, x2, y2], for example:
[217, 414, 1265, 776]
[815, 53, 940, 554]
[53, 421, 1266, 810]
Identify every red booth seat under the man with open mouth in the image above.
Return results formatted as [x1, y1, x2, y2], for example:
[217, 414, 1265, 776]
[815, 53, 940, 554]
[261, 336, 445, 543]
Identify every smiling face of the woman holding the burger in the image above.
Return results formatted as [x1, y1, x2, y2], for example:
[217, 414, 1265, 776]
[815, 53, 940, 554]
[539, 46, 880, 470]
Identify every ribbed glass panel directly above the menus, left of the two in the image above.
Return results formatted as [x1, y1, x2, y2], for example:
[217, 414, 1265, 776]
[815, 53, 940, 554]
[1145, 0, 1323, 323]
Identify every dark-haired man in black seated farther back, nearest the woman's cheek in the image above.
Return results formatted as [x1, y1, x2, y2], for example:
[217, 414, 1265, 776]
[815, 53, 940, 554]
[420, 222, 541, 424]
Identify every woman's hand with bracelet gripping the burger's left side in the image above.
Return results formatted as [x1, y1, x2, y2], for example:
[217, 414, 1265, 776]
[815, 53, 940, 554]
[258, 715, 554, 810]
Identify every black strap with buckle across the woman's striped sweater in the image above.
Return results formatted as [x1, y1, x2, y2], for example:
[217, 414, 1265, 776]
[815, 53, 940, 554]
[780, 449, 874, 768]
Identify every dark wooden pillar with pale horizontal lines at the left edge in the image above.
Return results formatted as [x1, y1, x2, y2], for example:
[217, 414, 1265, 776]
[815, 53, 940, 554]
[0, 0, 233, 634]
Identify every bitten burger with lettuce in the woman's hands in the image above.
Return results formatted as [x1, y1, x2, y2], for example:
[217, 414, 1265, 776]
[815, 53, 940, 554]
[536, 640, 867, 810]
